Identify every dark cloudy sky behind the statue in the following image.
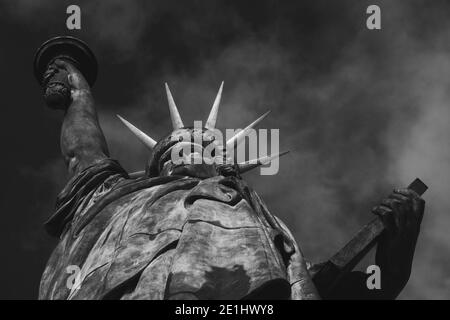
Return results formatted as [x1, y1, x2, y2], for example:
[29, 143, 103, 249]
[0, 0, 450, 299]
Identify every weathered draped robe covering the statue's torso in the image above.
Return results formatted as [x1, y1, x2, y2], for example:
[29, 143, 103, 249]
[40, 159, 316, 299]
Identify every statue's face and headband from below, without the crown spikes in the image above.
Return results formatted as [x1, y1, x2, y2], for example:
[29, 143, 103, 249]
[148, 128, 222, 177]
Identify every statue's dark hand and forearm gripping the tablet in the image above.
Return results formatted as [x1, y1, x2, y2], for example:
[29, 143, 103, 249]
[372, 189, 425, 295]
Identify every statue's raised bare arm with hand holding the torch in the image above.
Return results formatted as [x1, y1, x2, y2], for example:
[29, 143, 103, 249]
[34, 37, 108, 176]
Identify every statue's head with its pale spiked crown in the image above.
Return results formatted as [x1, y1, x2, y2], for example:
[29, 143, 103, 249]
[118, 82, 287, 177]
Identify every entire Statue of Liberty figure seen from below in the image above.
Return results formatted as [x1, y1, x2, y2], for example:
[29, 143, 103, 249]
[34, 37, 424, 300]
